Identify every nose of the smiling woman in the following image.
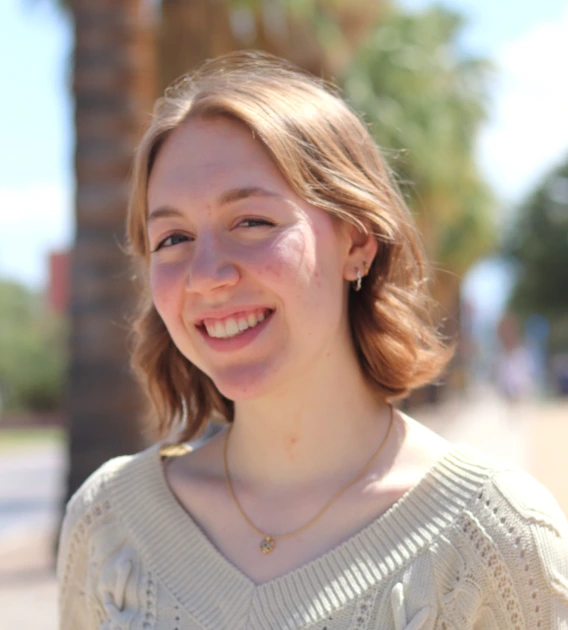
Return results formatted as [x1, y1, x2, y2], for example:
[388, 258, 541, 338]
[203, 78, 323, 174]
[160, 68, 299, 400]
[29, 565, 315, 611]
[185, 234, 240, 293]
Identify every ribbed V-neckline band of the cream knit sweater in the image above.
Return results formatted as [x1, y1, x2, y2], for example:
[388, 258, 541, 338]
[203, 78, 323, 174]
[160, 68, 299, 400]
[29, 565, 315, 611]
[112, 444, 490, 630]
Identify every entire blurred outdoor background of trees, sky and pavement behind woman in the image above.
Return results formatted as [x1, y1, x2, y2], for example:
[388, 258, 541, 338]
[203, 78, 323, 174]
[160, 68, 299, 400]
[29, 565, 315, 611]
[0, 0, 568, 630]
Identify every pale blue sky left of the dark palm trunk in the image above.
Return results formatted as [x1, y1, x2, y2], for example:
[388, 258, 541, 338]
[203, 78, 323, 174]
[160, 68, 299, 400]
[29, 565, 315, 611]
[0, 0, 73, 287]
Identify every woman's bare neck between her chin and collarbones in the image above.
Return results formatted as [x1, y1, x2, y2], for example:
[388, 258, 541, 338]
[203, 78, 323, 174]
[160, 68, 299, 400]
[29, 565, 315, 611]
[228, 344, 390, 495]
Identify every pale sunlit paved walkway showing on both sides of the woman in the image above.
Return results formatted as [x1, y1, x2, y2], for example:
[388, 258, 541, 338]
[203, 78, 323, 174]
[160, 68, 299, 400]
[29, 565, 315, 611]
[0, 390, 568, 630]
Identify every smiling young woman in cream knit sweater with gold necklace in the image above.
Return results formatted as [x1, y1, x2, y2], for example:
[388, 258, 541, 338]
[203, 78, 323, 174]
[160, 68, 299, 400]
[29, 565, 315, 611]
[58, 53, 568, 630]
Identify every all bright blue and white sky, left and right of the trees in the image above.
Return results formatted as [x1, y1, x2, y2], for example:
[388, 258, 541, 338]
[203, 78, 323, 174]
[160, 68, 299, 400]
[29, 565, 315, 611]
[0, 0, 568, 312]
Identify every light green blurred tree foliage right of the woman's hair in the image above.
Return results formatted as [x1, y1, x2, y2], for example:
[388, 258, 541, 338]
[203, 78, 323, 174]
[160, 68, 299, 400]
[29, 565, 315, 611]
[344, 7, 494, 273]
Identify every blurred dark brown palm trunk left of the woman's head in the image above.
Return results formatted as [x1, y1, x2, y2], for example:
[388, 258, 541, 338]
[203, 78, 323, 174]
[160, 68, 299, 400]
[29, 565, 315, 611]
[66, 0, 155, 504]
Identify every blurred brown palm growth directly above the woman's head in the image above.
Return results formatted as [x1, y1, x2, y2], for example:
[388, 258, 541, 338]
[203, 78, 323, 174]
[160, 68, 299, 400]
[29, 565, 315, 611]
[159, 0, 387, 92]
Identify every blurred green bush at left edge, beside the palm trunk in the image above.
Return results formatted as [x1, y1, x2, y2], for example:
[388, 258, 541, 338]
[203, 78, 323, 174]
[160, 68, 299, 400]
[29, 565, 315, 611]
[0, 281, 66, 411]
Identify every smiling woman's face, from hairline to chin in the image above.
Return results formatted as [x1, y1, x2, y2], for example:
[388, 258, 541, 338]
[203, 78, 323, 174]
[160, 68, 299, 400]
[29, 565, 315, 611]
[148, 118, 358, 401]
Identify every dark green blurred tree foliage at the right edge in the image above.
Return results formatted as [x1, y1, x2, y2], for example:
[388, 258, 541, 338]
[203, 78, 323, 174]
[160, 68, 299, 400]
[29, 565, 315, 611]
[506, 159, 568, 320]
